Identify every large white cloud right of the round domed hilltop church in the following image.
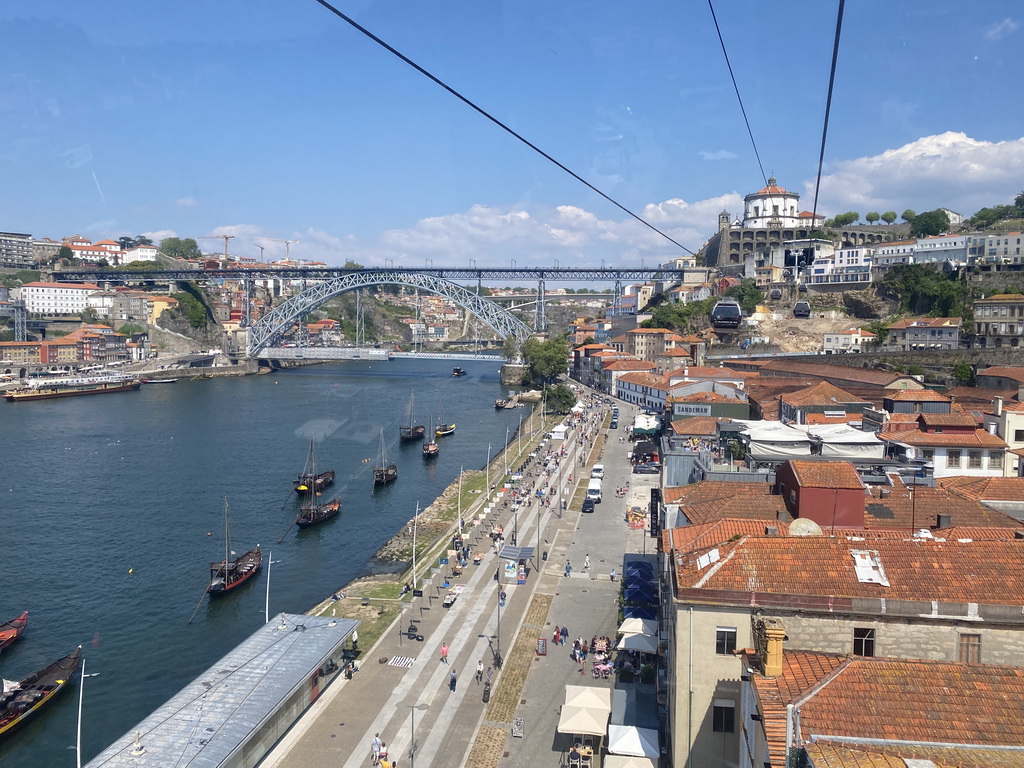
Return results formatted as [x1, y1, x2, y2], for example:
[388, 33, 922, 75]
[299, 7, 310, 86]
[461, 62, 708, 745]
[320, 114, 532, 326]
[804, 131, 1024, 215]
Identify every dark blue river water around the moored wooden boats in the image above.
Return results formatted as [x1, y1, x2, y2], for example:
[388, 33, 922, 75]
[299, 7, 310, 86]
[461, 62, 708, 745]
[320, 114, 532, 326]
[0, 360, 529, 768]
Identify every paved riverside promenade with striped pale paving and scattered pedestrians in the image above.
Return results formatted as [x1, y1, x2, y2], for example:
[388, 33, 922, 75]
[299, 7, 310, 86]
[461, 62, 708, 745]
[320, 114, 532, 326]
[260, 393, 657, 768]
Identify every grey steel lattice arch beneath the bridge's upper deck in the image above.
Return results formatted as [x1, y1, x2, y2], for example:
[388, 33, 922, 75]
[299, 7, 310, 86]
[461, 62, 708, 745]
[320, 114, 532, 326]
[248, 269, 532, 357]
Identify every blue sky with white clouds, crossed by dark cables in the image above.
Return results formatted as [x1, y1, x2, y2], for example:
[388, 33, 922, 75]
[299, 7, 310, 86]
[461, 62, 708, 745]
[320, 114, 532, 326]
[0, 0, 1024, 266]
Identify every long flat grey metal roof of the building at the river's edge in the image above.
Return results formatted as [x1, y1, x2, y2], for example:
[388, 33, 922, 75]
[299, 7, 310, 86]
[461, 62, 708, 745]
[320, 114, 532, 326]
[86, 613, 359, 768]
